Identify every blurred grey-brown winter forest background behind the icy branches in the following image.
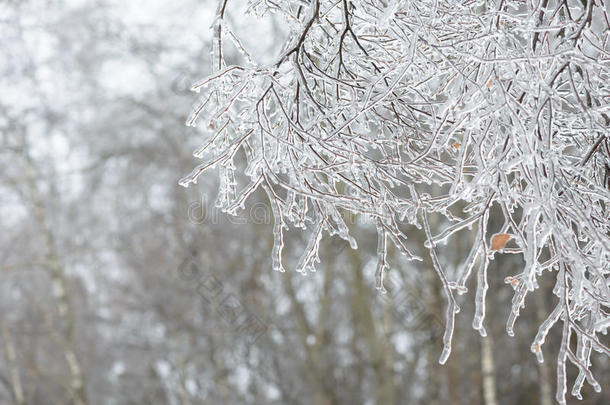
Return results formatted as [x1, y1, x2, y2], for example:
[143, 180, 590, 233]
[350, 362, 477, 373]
[0, 0, 610, 405]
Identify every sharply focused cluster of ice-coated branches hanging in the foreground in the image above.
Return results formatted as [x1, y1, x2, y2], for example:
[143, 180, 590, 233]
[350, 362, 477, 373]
[181, 0, 610, 403]
